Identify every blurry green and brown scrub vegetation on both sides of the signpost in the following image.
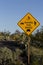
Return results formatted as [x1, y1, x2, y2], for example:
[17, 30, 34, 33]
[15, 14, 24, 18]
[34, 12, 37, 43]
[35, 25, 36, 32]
[0, 26, 43, 65]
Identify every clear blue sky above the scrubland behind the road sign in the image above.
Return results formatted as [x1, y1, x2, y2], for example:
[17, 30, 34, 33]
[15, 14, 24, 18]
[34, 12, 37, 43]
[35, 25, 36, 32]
[0, 0, 43, 32]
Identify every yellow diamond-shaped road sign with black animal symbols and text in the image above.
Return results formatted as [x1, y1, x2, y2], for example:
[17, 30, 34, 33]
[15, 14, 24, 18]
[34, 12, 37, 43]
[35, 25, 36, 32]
[17, 13, 40, 35]
